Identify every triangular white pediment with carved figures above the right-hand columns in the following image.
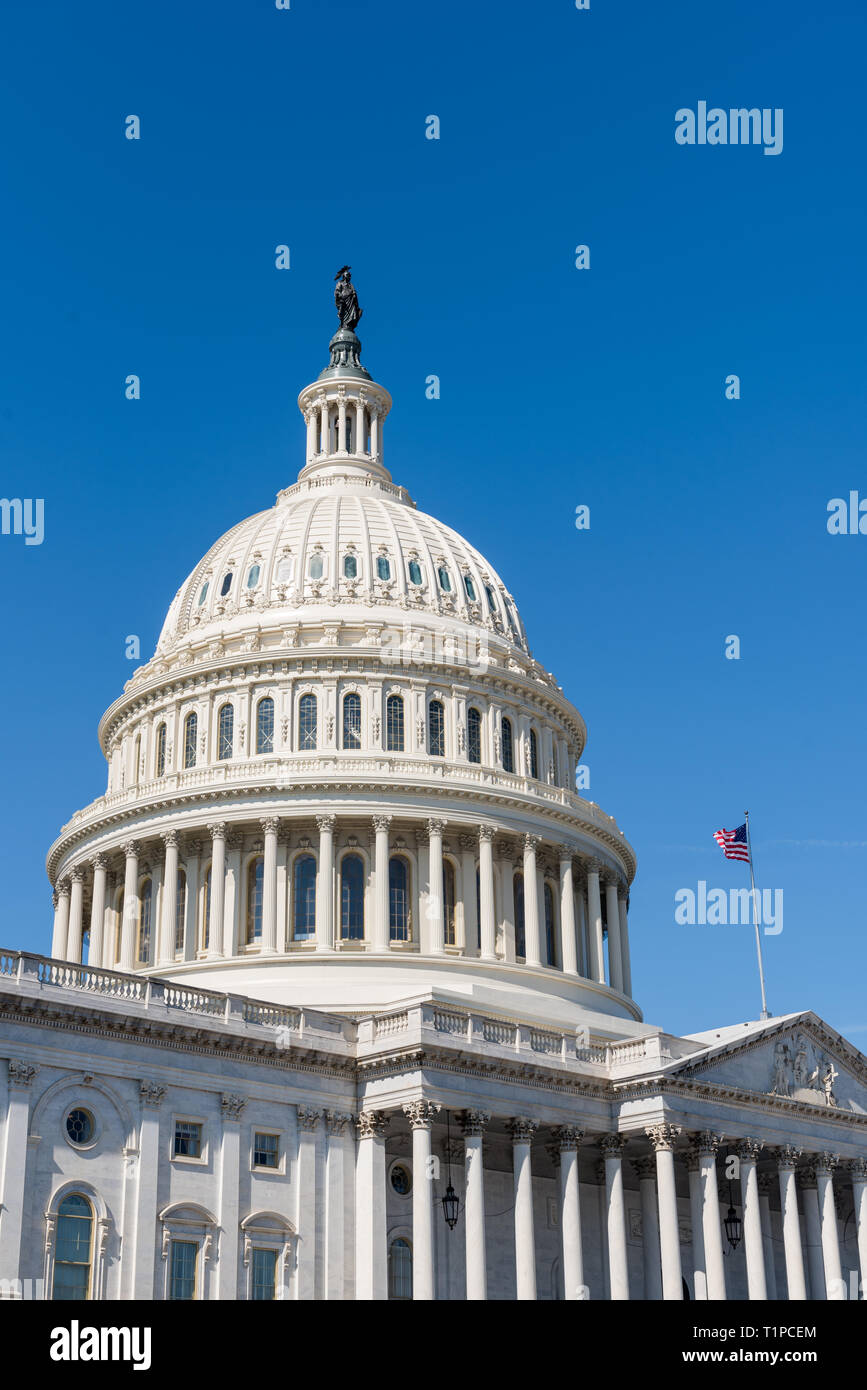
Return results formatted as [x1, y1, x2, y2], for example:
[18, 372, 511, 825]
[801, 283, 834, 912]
[677, 1013, 867, 1115]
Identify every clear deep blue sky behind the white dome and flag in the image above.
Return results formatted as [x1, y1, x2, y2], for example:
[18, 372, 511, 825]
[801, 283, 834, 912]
[0, 0, 867, 1047]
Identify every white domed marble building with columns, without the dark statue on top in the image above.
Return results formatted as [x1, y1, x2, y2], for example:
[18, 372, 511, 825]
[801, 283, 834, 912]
[0, 319, 867, 1301]
